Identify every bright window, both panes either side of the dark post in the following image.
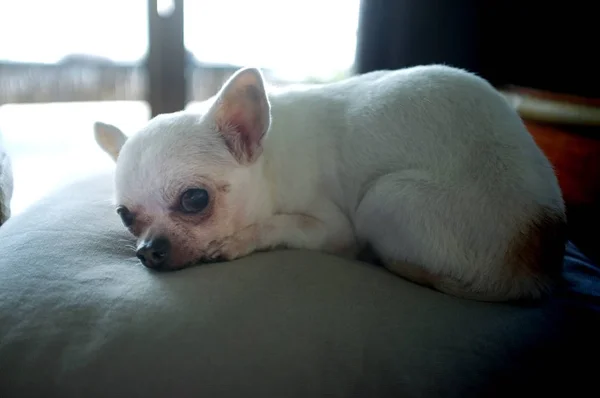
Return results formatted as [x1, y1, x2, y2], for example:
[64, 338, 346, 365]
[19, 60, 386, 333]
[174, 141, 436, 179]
[0, 0, 359, 214]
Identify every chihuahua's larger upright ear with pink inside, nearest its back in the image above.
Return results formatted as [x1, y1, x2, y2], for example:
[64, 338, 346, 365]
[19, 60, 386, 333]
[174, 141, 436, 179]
[209, 68, 271, 163]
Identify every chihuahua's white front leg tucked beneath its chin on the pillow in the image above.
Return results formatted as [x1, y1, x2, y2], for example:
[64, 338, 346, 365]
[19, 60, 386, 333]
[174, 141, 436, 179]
[206, 214, 357, 260]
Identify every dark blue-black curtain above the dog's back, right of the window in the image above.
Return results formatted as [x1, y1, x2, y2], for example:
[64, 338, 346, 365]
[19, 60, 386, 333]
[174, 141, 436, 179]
[355, 0, 600, 97]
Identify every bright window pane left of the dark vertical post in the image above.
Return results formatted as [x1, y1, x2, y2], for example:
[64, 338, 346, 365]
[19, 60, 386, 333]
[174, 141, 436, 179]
[0, 0, 150, 214]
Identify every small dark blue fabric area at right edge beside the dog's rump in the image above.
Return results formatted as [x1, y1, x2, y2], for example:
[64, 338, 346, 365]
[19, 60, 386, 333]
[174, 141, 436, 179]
[559, 242, 600, 313]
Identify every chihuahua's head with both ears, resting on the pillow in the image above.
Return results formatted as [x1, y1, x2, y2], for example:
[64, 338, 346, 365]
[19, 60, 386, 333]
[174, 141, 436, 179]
[94, 68, 271, 269]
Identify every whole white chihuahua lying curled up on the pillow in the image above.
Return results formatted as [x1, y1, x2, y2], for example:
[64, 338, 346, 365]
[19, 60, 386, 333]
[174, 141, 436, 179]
[94, 65, 566, 301]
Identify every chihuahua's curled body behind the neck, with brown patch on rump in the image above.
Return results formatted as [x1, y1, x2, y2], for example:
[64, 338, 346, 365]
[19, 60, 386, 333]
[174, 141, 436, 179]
[274, 65, 566, 300]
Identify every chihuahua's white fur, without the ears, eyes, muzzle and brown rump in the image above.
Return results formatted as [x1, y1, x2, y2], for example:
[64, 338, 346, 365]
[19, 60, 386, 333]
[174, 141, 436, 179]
[95, 65, 564, 299]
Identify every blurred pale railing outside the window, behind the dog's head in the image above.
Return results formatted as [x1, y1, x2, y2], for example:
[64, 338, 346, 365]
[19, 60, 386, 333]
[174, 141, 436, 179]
[0, 57, 287, 105]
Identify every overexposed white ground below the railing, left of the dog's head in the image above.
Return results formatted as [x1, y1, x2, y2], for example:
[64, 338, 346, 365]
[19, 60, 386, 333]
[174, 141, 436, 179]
[0, 102, 150, 215]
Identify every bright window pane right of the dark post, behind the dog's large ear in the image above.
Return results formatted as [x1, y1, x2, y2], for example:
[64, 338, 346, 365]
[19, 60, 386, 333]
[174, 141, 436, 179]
[184, 0, 360, 105]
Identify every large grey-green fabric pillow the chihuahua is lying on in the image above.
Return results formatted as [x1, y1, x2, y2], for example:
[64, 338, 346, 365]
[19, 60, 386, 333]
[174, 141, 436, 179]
[0, 175, 585, 398]
